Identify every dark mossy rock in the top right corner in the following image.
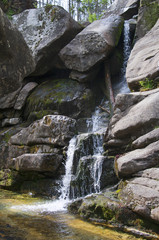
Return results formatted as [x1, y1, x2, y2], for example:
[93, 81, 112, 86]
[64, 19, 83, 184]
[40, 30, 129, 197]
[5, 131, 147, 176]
[135, 0, 159, 39]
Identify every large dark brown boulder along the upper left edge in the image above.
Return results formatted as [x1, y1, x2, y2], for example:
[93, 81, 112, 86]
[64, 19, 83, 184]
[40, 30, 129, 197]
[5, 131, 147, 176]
[0, 9, 35, 109]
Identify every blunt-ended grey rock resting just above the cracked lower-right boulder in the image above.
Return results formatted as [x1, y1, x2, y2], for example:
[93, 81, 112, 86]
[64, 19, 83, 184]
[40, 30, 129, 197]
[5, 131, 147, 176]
[116, 141, 159, 177]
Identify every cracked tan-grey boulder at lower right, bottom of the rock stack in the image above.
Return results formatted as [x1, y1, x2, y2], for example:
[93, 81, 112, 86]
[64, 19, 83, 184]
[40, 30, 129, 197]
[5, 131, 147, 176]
[120, 168, 159, 223]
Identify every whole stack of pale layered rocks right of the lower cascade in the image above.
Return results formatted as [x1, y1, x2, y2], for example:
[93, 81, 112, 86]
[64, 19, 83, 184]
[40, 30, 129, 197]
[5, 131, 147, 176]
[105, 89, 159, 223]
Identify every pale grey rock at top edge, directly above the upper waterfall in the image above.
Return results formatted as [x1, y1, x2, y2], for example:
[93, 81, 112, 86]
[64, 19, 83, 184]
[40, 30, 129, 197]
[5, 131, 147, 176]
[103, 0, 140, 20]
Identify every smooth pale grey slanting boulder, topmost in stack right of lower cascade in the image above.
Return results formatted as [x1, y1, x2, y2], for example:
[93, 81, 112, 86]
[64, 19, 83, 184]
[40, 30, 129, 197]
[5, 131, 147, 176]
[109, 92, 159, 138]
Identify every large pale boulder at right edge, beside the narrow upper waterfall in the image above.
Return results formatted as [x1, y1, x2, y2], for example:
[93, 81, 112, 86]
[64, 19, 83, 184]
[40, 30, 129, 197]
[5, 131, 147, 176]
[126, 20, 159, 90]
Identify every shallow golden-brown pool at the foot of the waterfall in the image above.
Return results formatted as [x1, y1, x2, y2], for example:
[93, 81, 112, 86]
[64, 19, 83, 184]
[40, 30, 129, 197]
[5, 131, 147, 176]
[0, 190, 142, 240]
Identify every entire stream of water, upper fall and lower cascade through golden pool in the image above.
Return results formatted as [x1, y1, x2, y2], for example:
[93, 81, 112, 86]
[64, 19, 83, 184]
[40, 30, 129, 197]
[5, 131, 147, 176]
[0, 23, 136, 240]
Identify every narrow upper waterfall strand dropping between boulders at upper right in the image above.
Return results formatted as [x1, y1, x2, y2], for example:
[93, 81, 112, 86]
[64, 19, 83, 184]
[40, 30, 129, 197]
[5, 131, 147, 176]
[114, 21, 131, 94]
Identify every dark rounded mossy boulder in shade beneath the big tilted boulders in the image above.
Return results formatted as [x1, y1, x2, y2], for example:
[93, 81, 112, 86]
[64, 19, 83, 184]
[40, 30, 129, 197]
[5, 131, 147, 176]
[24, 79, 95, 120]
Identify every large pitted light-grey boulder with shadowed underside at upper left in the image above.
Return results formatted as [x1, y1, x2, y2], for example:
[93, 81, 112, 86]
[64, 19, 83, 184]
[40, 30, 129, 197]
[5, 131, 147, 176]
[13, 5, 82, 75]
